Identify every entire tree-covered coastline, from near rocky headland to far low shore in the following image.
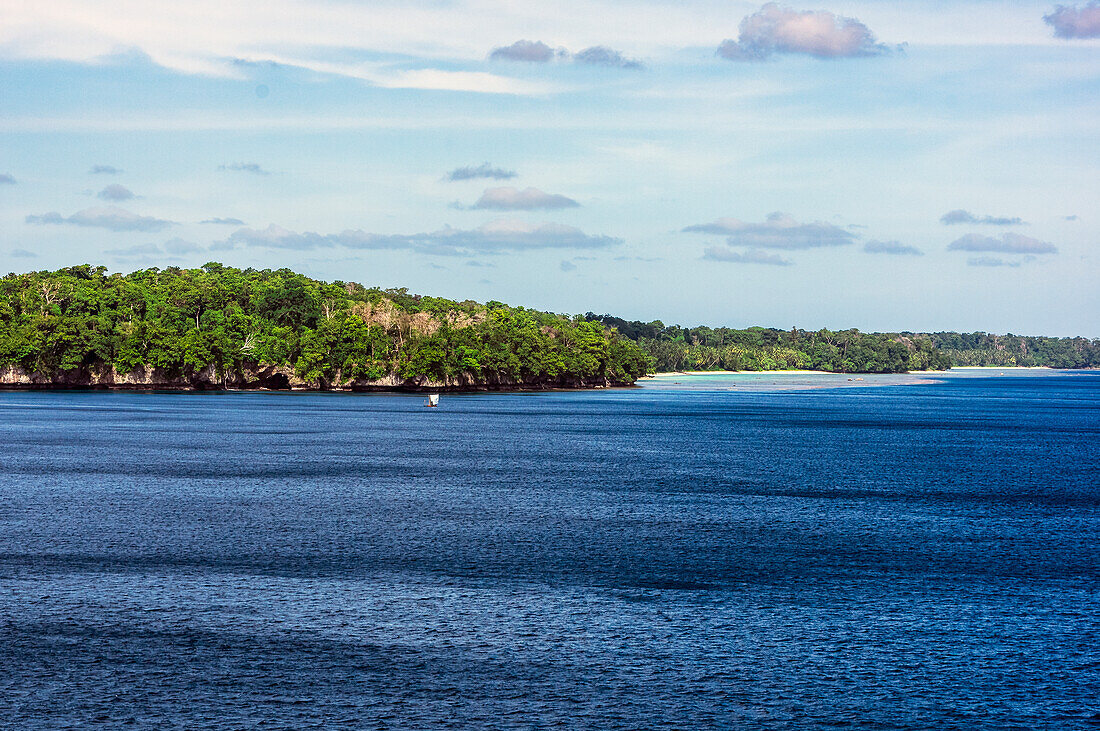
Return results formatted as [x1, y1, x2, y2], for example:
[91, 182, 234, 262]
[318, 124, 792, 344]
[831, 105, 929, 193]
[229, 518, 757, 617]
[0, 263, 1100, 391]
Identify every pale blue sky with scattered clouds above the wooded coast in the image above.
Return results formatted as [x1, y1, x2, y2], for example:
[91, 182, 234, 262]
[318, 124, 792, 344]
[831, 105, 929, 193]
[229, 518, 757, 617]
[0, 0, 1100, 337]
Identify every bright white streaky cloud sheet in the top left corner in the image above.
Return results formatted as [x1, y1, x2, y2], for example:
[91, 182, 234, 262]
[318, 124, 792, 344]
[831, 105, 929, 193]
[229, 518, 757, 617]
[0, 0, 563, 93]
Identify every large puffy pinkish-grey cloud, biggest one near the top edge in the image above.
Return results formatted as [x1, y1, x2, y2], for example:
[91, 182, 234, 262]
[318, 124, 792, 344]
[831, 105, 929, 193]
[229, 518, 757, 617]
[718, 2, 888, 60]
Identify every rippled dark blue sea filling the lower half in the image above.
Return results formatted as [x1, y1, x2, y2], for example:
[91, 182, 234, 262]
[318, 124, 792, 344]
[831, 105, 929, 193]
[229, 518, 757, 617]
[0, 374, 1100, 729]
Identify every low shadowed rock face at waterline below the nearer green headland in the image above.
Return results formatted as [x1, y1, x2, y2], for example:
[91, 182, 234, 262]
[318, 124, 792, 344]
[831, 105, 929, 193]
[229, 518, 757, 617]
[0, 365, 634, 391]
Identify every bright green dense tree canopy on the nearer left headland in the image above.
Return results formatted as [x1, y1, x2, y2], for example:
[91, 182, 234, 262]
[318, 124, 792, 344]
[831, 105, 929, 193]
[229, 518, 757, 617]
[0, 263, 648, 388]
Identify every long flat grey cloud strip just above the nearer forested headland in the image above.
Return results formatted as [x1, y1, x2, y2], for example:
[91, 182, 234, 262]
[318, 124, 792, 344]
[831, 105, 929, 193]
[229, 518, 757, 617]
[219, 220, 623, 256]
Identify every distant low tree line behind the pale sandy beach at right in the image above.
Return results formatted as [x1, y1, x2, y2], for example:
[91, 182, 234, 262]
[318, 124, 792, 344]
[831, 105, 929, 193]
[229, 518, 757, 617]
[585, 312, 1100, 373]
